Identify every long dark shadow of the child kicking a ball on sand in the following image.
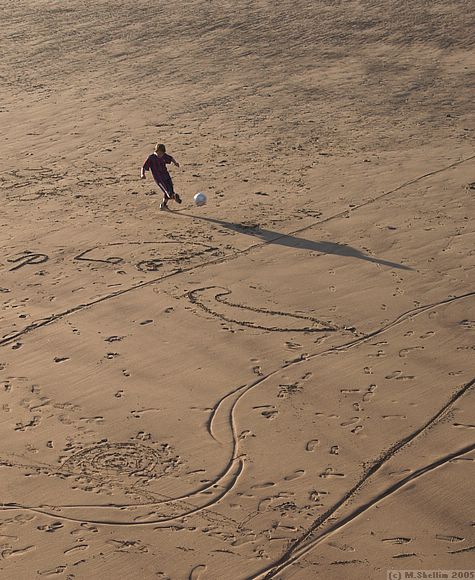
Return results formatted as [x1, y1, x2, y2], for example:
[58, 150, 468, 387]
[177, 212, 413, 270]
